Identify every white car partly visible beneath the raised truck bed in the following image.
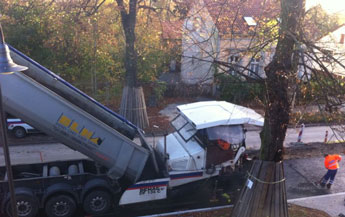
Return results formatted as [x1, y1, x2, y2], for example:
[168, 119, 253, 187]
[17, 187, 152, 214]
[7, 118, 38, 138]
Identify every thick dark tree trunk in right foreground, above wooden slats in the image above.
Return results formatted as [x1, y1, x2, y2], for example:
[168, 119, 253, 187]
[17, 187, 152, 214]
[260, 0, 305, 162]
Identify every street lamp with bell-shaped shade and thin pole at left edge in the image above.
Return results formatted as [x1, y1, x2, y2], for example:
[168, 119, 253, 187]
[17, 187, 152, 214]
[0, 23, 27, 217]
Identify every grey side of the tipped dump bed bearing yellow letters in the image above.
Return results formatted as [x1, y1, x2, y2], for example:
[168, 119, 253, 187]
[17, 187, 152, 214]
[0, 73, 149, 182]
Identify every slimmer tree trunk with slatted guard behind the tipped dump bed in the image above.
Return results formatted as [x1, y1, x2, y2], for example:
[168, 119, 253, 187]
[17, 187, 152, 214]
[117, 0, 149, 128]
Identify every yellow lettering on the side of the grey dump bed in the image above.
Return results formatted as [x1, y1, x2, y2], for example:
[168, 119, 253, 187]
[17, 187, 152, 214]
[57, 114, 103, 145]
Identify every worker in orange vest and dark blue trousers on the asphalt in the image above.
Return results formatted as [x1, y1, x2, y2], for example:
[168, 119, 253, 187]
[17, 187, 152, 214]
[320, 154, 341, 189]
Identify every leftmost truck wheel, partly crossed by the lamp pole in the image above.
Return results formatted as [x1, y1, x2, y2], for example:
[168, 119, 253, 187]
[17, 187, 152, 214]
[6, 194, 39, 217]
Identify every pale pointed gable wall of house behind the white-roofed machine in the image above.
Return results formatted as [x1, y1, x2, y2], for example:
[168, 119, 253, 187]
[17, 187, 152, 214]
[181, 0, 219, 85]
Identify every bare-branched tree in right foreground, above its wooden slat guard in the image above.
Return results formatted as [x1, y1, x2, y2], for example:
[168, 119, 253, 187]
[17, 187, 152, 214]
[177, 0, 345, 161]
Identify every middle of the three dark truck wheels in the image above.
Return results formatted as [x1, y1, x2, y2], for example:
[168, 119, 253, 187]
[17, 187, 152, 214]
[45, 195, 77, 217]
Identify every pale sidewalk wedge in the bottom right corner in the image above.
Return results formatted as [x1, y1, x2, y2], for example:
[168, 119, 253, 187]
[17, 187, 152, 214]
[288, 192, 345, 217]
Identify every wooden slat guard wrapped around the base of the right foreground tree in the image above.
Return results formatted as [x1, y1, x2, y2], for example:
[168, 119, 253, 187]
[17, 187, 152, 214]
[231, 161, 289, 217]
